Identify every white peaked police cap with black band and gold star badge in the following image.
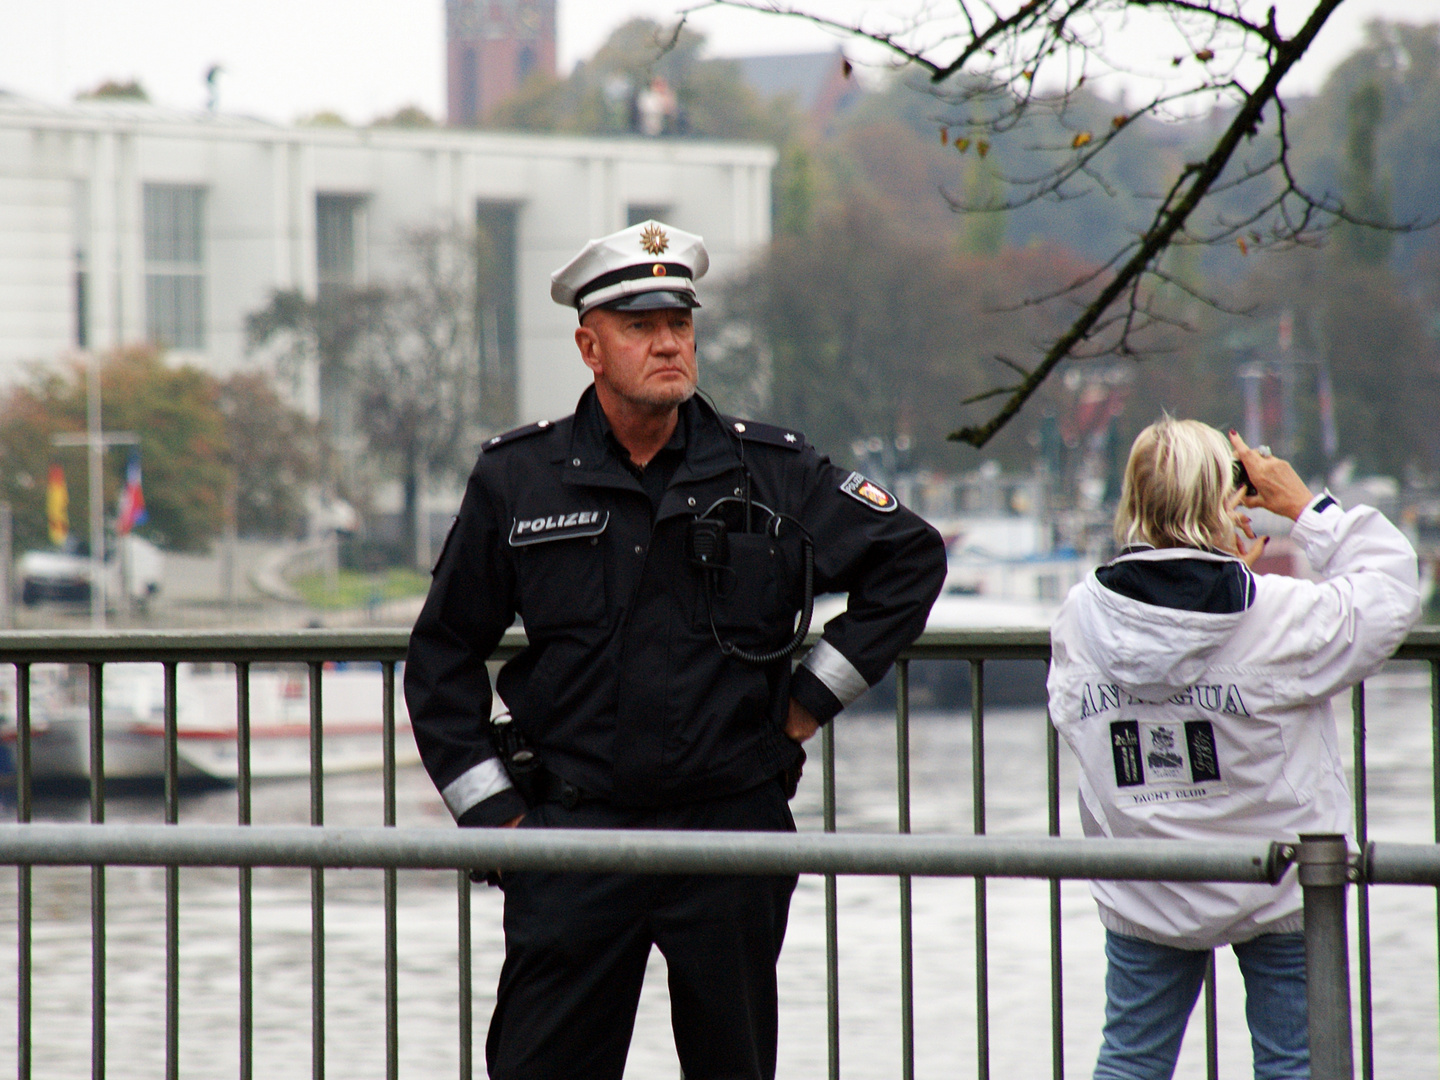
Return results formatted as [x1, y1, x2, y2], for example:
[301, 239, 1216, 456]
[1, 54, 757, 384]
[550, 220, 710, 315]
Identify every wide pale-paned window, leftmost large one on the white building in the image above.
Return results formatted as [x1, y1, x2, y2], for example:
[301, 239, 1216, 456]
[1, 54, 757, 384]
[144, 184, 204, 348]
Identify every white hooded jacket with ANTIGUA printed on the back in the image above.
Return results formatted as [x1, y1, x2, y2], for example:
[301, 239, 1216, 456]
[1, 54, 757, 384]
[1048, 495, 1420, 949]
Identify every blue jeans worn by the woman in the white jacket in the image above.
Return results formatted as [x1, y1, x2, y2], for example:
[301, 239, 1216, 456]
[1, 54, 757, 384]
[1094, 930, 1310, 1080]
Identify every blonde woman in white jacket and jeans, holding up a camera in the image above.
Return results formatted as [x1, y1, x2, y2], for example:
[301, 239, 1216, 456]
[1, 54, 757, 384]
[1050, 418, 1420, 1080]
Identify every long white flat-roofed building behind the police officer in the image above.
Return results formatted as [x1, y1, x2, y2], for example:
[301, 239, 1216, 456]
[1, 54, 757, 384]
[0, 94, 775, 422]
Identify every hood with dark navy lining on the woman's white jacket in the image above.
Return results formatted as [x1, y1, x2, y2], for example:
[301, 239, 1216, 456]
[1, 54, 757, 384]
[1076, 549, 1254, 701]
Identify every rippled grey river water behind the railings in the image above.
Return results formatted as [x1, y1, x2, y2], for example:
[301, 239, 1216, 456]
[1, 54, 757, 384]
[0, 665, 1440, 1080]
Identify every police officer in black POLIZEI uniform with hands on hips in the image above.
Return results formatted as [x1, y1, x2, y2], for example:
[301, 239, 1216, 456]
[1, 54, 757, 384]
[405, 222, 945, 1080]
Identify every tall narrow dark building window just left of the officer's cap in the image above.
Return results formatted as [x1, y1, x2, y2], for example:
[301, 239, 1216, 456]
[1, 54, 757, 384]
[475, 202, 520, 428]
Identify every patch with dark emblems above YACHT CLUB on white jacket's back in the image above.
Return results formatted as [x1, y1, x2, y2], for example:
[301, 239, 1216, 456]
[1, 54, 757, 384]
[1110, 720, 1230, 805]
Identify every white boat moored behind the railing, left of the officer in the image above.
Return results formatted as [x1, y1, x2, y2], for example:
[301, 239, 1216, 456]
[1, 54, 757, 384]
[0, 664, 419, 782]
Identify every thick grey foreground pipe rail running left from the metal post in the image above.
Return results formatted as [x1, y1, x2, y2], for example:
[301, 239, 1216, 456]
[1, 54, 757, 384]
[0, 824, 1295, 884]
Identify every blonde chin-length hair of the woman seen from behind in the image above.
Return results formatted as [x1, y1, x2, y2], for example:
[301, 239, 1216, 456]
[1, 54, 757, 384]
[1115, 416, 1234, 550]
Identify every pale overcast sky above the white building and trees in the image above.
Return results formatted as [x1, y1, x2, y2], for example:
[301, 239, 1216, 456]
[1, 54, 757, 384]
[0, 0, 1440, 122]
